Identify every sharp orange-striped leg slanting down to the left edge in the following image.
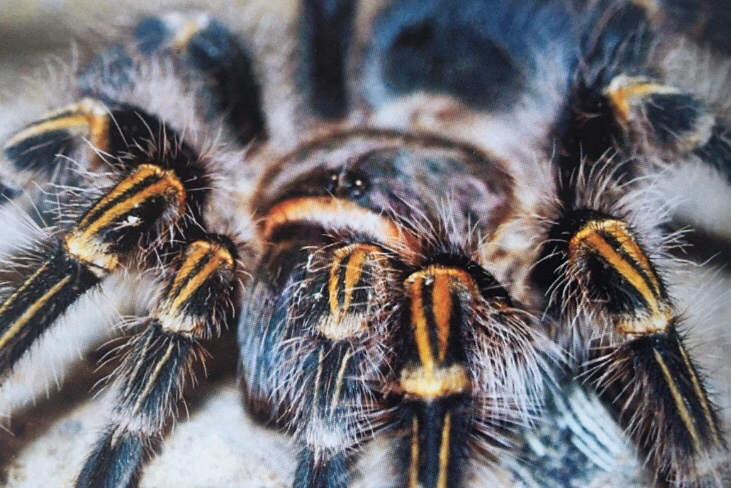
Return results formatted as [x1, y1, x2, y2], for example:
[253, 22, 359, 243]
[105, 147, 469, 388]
[0, 160, 192, 370]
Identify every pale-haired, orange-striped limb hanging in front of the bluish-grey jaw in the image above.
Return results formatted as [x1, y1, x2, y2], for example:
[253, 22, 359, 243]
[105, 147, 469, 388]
[287, 243, 394, 488]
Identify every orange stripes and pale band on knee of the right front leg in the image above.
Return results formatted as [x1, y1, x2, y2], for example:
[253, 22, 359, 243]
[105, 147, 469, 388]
[569, 218, 673, 335]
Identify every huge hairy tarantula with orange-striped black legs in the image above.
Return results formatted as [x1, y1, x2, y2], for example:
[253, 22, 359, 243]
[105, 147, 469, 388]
[0, 0, 731, 488]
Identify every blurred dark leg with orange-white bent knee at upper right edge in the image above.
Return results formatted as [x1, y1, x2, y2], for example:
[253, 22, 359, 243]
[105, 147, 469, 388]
[604, 75, 731, 246]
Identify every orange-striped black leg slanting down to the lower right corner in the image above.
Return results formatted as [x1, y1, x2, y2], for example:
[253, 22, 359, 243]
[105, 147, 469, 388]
[545, 209, 726, 486]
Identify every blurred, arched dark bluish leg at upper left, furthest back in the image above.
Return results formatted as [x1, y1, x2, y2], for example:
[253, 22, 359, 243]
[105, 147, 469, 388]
[79, 13, 266, 144]
